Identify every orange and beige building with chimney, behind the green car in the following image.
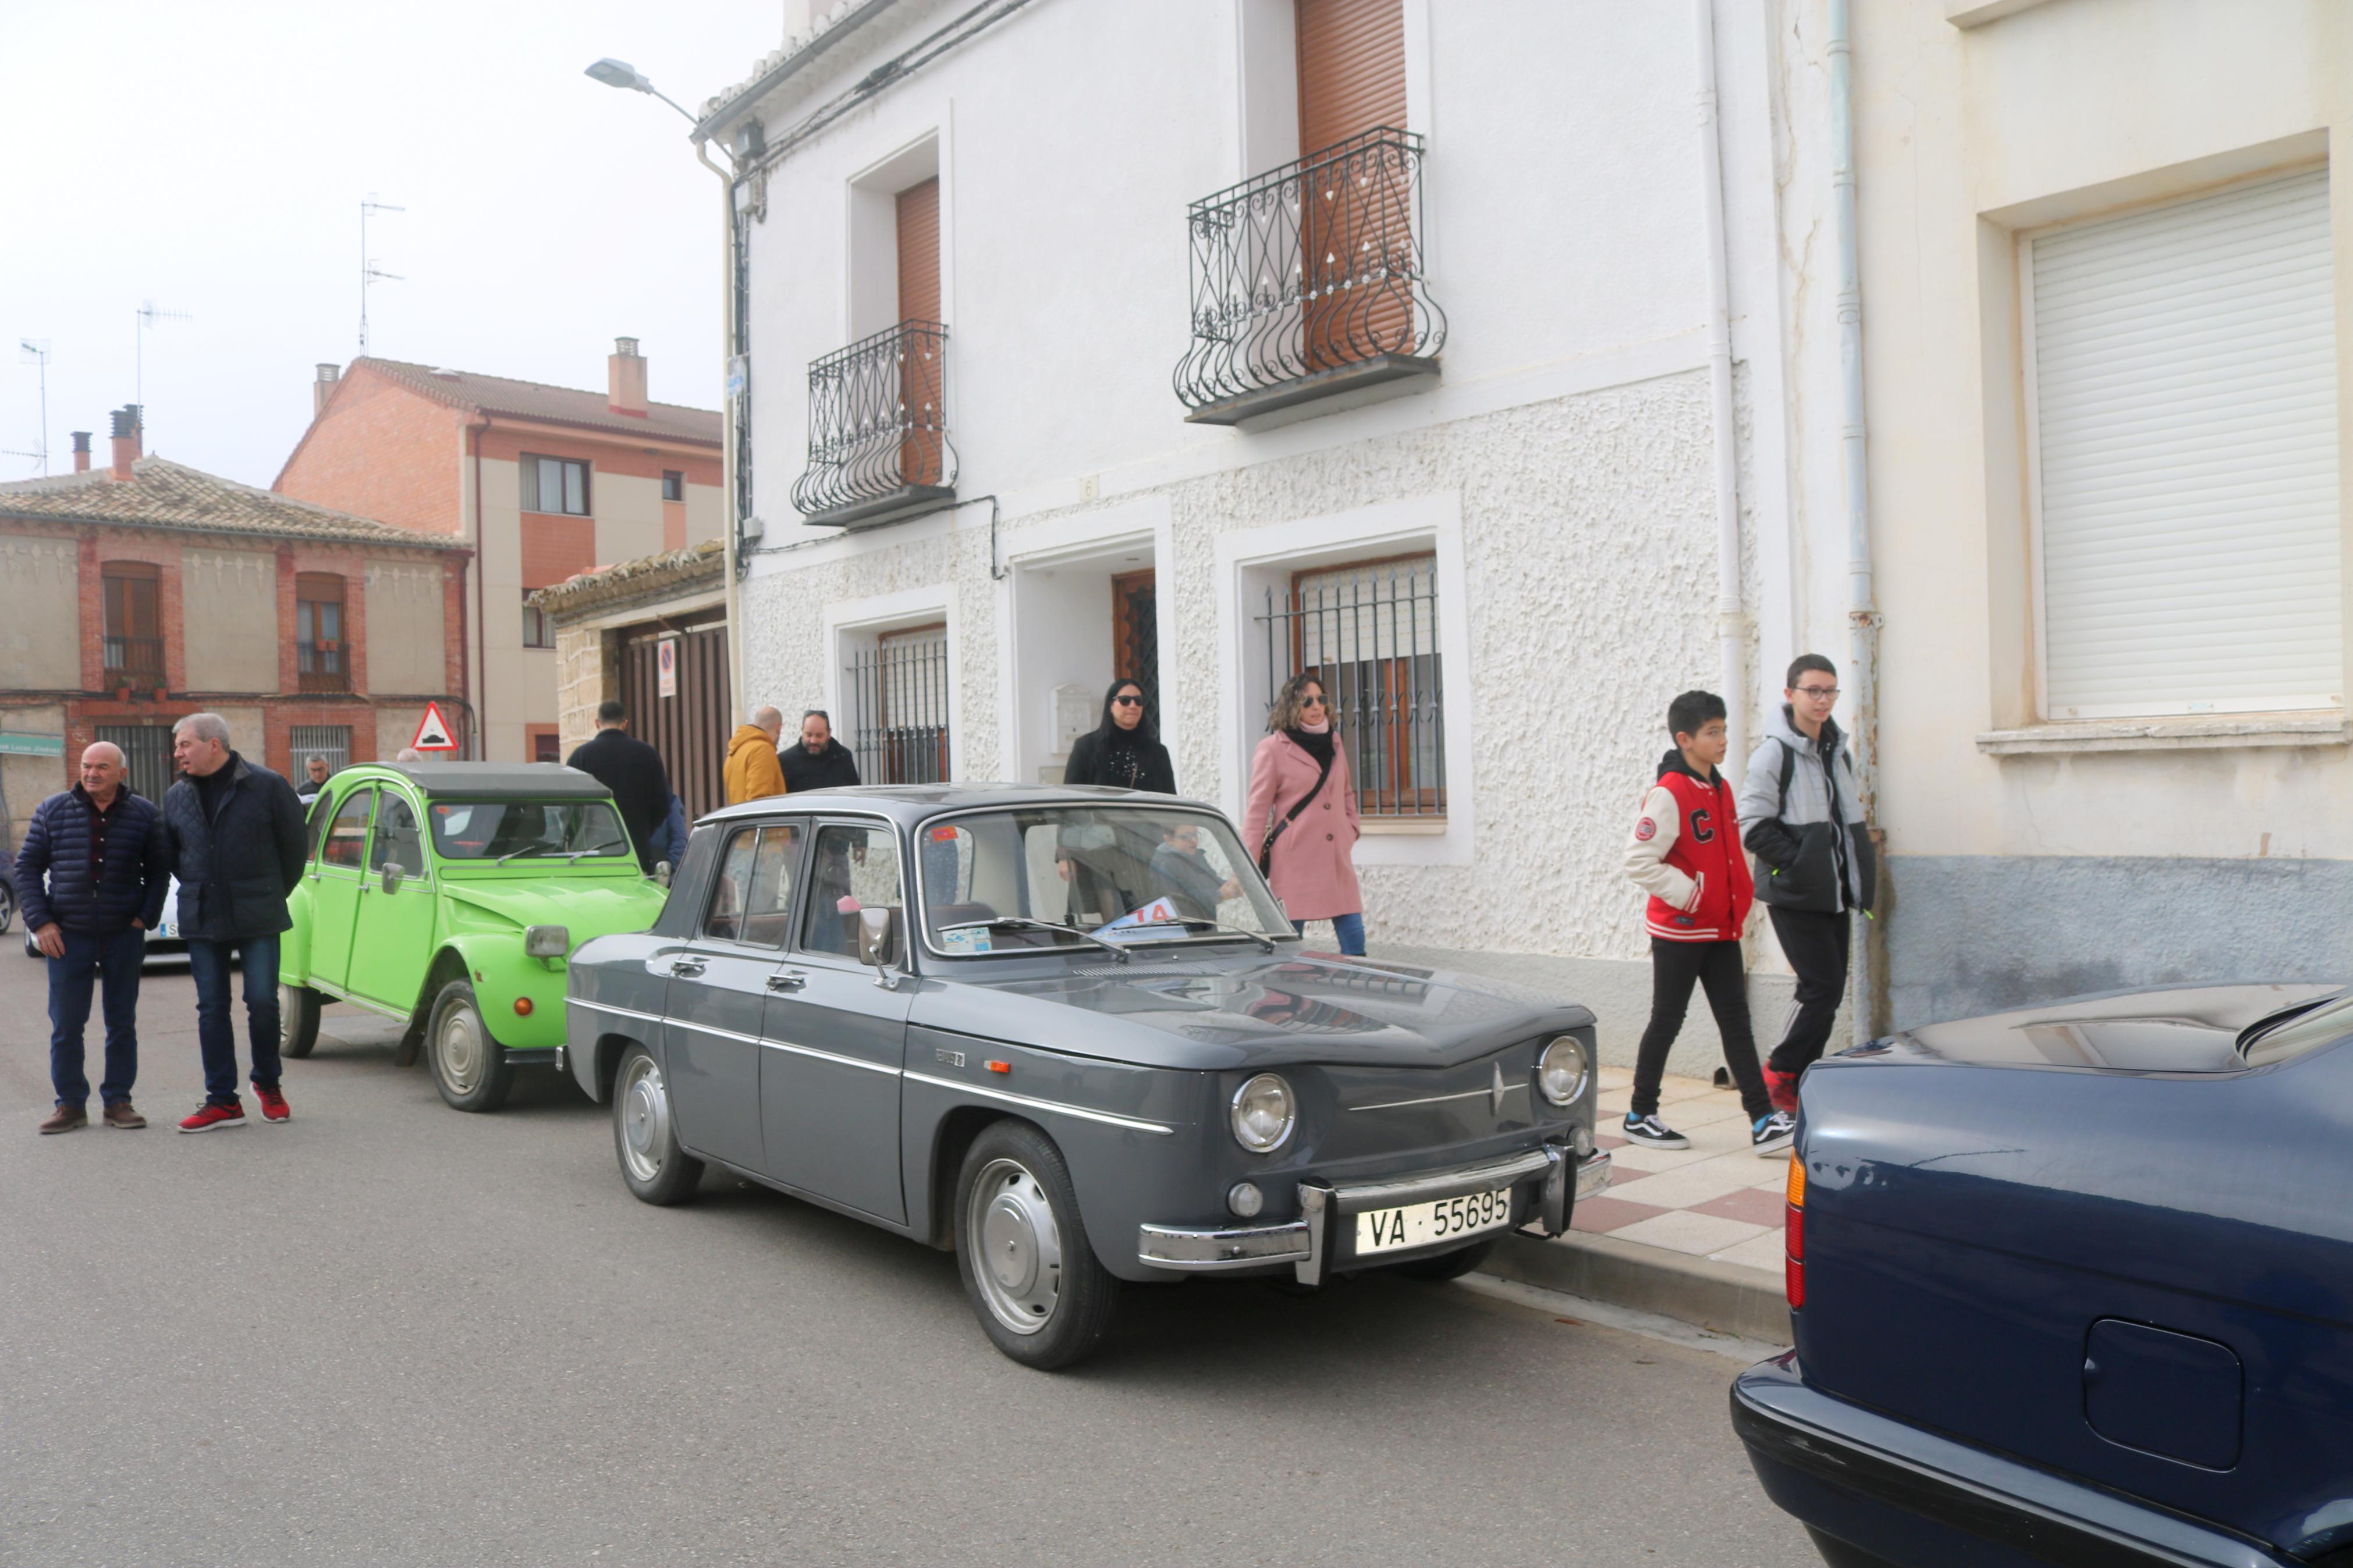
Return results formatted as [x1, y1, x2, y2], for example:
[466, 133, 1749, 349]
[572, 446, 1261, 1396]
[273, 339, 725, 762]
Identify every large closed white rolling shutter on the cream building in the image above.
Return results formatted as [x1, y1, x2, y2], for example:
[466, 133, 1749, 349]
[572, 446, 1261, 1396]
[2028, 169, 2344, 719]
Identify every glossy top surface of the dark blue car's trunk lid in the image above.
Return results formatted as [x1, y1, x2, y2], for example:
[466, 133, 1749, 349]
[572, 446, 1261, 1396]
[1864, 983, 2344, 1072]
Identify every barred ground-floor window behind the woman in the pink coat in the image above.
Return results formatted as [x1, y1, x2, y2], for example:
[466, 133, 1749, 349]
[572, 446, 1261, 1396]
[1259, 555, 1447, 820]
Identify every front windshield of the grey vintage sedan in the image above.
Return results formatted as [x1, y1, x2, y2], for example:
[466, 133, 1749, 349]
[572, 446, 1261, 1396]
[915, 806, 1292, 954]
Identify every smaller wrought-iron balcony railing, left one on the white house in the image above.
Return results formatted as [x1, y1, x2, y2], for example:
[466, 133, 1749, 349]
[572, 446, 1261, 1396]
[793, 322, 955, 524]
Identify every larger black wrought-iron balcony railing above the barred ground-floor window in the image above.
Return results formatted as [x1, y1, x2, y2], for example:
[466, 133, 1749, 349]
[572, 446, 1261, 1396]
[1174, 127, 1447, 425]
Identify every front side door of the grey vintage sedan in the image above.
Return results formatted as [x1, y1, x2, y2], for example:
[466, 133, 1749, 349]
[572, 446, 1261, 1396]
[760, 823, 913, 1225]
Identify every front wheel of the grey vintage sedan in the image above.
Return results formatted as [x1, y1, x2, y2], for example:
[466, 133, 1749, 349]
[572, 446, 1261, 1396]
[955, 1121, 1120, 1371]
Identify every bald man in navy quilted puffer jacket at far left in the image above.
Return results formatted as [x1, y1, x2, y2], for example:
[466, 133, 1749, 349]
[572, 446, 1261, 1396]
[16, 741, 172, 1133]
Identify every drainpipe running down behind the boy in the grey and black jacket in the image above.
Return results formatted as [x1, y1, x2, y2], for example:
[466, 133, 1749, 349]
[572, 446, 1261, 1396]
[1828, 0, 1884, 1041]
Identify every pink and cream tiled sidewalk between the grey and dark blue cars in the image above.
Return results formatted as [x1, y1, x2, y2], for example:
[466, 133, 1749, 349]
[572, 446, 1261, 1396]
[1572, 1067, 1788, 1290]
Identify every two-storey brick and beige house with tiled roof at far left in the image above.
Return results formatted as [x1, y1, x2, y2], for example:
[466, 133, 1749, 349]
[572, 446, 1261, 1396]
[0, 407, 471, 844]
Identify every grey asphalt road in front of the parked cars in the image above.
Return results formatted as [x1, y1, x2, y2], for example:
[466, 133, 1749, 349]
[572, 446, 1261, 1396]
[0, 938, 1814, 1568]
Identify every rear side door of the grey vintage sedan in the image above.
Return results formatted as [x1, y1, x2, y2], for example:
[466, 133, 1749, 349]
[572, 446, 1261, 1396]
[663, 823, 803, 1171]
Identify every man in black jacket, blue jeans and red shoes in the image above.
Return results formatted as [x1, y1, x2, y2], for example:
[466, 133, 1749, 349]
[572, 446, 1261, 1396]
[162, 712, 308, 1133]
